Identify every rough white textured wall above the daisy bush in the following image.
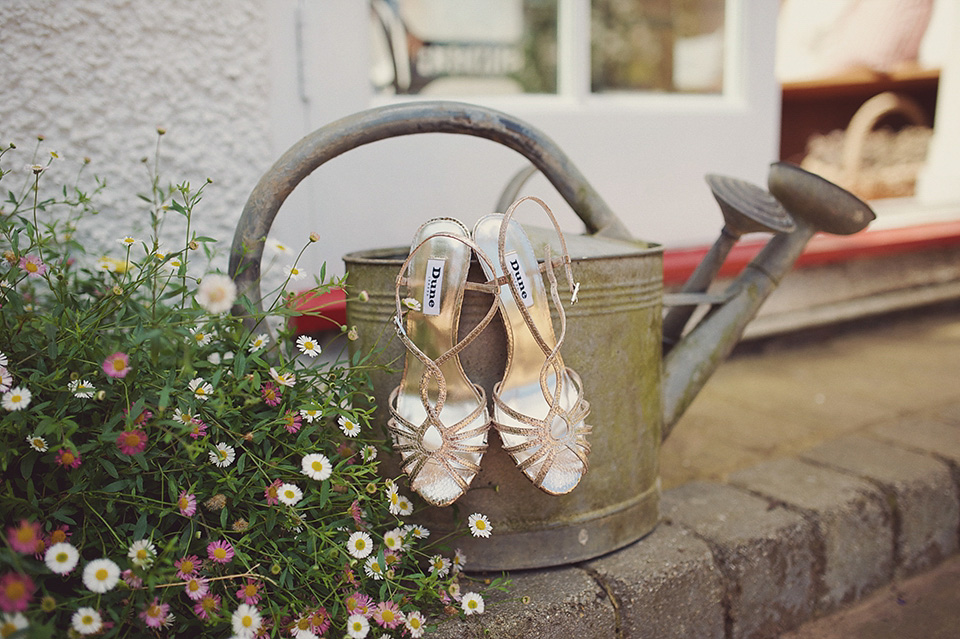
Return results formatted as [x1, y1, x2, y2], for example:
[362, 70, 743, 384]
[0, 0, 272, 267]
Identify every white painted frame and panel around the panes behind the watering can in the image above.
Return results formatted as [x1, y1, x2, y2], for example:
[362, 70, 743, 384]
[271, 0, 780, 266]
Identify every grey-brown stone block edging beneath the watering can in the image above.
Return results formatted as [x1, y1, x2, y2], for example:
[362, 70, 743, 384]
[433, 405, 960, 639]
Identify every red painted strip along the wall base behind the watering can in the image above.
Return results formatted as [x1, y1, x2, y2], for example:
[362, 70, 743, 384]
[291, 220, 960, 333]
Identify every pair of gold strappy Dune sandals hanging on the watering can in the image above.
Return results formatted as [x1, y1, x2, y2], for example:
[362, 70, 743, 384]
[388, 197, 590, 506]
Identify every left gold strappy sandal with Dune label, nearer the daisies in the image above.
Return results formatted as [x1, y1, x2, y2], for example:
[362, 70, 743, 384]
[387, 218, 498, 506]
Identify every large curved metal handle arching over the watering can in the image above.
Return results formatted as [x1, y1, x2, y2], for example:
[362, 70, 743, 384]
[229, 101, 630, 316]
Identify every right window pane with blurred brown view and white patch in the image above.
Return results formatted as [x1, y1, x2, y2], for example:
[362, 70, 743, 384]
[590, 0, 724, 93]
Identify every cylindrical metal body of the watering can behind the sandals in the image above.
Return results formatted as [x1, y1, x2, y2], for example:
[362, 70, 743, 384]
[344, 228, 663, 570]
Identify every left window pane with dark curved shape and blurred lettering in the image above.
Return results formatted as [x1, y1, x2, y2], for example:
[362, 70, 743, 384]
[370, 0, 557, 95]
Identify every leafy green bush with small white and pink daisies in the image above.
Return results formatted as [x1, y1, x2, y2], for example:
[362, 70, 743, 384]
[0, 132, 501, 637]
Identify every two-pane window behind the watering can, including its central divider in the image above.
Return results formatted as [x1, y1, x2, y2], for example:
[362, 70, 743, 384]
[370, 0, 725, 96]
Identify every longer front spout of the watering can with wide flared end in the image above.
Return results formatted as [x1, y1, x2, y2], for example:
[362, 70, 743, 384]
[661, 162, 876, 439]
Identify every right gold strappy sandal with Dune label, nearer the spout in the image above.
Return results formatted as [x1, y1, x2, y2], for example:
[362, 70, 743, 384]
[473, 197, 591, 495]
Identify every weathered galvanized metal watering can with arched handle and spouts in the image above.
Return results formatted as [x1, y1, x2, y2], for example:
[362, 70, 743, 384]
[230, 102, 874, 570]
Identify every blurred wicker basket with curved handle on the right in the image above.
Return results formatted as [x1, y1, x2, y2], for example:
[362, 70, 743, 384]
[801, 91, 933, 200]
